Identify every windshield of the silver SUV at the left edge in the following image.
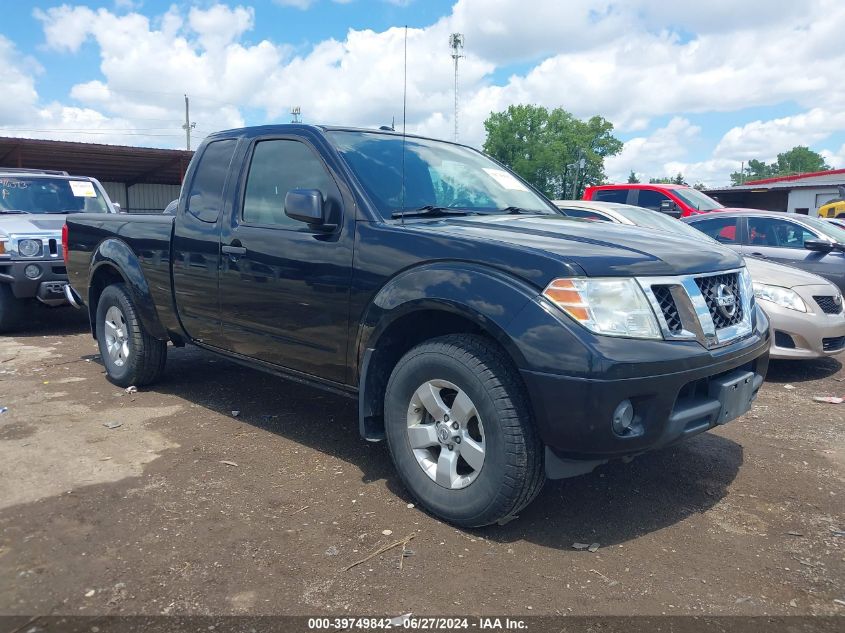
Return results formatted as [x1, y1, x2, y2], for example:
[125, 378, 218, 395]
[0, 176, 108, 213]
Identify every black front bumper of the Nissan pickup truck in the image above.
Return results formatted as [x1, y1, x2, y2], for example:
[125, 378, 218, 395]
[520, 302, 770, 478]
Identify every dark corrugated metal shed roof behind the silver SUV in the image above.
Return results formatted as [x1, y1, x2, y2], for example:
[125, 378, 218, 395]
[0, 137, 193, 185]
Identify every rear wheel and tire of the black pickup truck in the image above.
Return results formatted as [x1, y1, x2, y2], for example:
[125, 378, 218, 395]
[96, 284, 167, 387]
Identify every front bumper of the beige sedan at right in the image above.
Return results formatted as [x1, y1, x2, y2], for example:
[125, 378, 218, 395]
[760, 286, 845, 360]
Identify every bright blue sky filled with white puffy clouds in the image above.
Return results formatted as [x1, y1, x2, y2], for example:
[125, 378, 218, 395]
[0, 0, 845, 186]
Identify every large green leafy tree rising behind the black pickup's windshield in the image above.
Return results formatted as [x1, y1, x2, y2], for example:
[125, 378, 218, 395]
[484, 105, 622, 198]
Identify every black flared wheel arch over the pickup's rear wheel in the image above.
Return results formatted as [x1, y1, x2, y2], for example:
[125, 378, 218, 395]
[88, 238, 169, 341]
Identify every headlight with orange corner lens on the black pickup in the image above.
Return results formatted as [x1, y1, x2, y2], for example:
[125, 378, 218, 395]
[543, 278, 663, 339]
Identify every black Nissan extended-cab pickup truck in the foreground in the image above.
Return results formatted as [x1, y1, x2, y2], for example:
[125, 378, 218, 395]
[64, 125, 769, 526]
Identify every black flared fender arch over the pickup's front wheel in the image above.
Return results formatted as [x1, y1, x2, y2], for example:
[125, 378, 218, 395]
[352, 263, 537, 441]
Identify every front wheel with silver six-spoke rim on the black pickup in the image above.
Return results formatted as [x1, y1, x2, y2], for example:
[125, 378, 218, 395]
[385, 334, 545, 527]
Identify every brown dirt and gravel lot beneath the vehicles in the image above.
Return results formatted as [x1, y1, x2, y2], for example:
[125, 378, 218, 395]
[0, 310, 845, 615]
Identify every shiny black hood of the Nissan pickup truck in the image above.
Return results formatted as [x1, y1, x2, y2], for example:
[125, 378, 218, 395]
[407, 215, 743, 277]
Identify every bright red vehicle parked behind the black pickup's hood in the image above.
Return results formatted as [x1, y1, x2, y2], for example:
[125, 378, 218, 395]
[584, 184, 726, 218]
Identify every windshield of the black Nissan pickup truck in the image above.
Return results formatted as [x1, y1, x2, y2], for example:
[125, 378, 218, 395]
[328, 131, 560, 218]
